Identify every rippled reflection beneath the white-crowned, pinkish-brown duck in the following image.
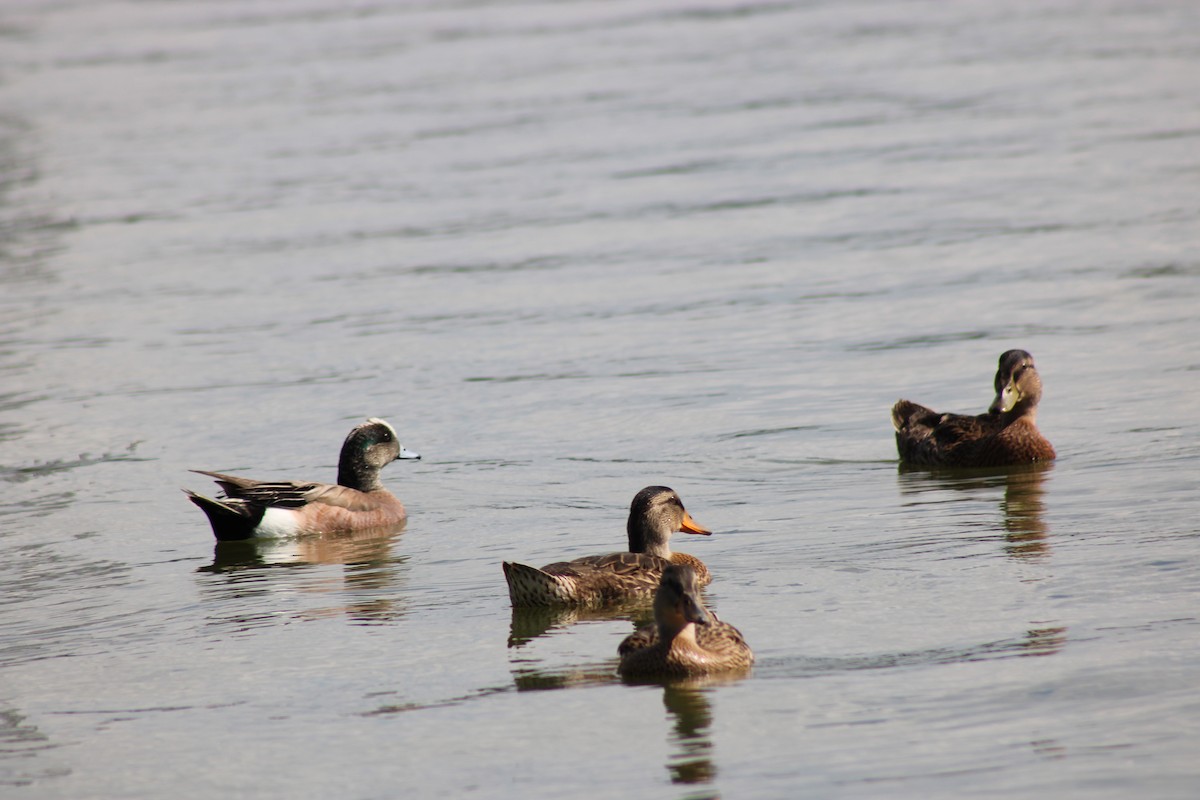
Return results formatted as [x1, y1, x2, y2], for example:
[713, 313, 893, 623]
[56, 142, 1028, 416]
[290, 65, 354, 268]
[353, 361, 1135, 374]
[197, 525, 408, 628]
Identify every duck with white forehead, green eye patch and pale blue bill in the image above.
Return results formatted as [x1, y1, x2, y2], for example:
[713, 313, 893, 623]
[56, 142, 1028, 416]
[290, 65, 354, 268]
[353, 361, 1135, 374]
[184, 417, 420, 542]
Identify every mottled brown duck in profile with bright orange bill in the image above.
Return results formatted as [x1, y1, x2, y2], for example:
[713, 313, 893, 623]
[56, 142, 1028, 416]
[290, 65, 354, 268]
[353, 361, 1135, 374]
[503, 486, 713, 607]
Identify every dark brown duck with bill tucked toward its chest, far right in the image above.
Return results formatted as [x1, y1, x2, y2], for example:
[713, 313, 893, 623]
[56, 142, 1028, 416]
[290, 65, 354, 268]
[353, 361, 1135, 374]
[892, 350, 1057, 467]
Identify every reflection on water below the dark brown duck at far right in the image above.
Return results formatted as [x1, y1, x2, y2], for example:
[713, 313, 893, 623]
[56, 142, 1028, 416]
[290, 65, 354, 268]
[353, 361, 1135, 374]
[900, 462, 1054, 559]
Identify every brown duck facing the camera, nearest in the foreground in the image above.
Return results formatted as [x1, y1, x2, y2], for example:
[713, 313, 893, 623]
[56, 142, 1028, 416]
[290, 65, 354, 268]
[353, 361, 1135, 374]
[617, 564, 754, 678]
